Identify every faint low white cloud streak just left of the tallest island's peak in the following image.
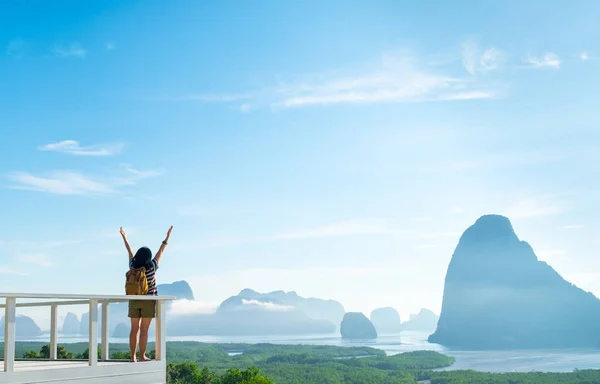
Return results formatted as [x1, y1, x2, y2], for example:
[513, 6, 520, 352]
[273, 219, 407, 240]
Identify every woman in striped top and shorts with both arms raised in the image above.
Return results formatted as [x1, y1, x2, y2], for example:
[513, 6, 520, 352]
[120, 226, 173, 363]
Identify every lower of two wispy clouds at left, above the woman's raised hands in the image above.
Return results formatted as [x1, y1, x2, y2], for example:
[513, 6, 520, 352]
[8, 168, 164, 195]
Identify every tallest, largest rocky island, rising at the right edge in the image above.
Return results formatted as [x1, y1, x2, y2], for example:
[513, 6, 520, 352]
[429, 215, 600, 350]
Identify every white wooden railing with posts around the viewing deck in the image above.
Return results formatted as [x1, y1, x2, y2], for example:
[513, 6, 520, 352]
[0, 293, 175, 372]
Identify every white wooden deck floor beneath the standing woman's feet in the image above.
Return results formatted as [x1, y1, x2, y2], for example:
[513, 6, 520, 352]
[0, 360, 166, 384]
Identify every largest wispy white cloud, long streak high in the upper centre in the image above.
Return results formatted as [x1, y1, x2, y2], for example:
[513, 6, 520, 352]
[160, 48, 502, 112]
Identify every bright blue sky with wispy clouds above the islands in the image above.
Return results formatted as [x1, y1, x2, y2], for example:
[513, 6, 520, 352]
[0, 0, 600, 318]
